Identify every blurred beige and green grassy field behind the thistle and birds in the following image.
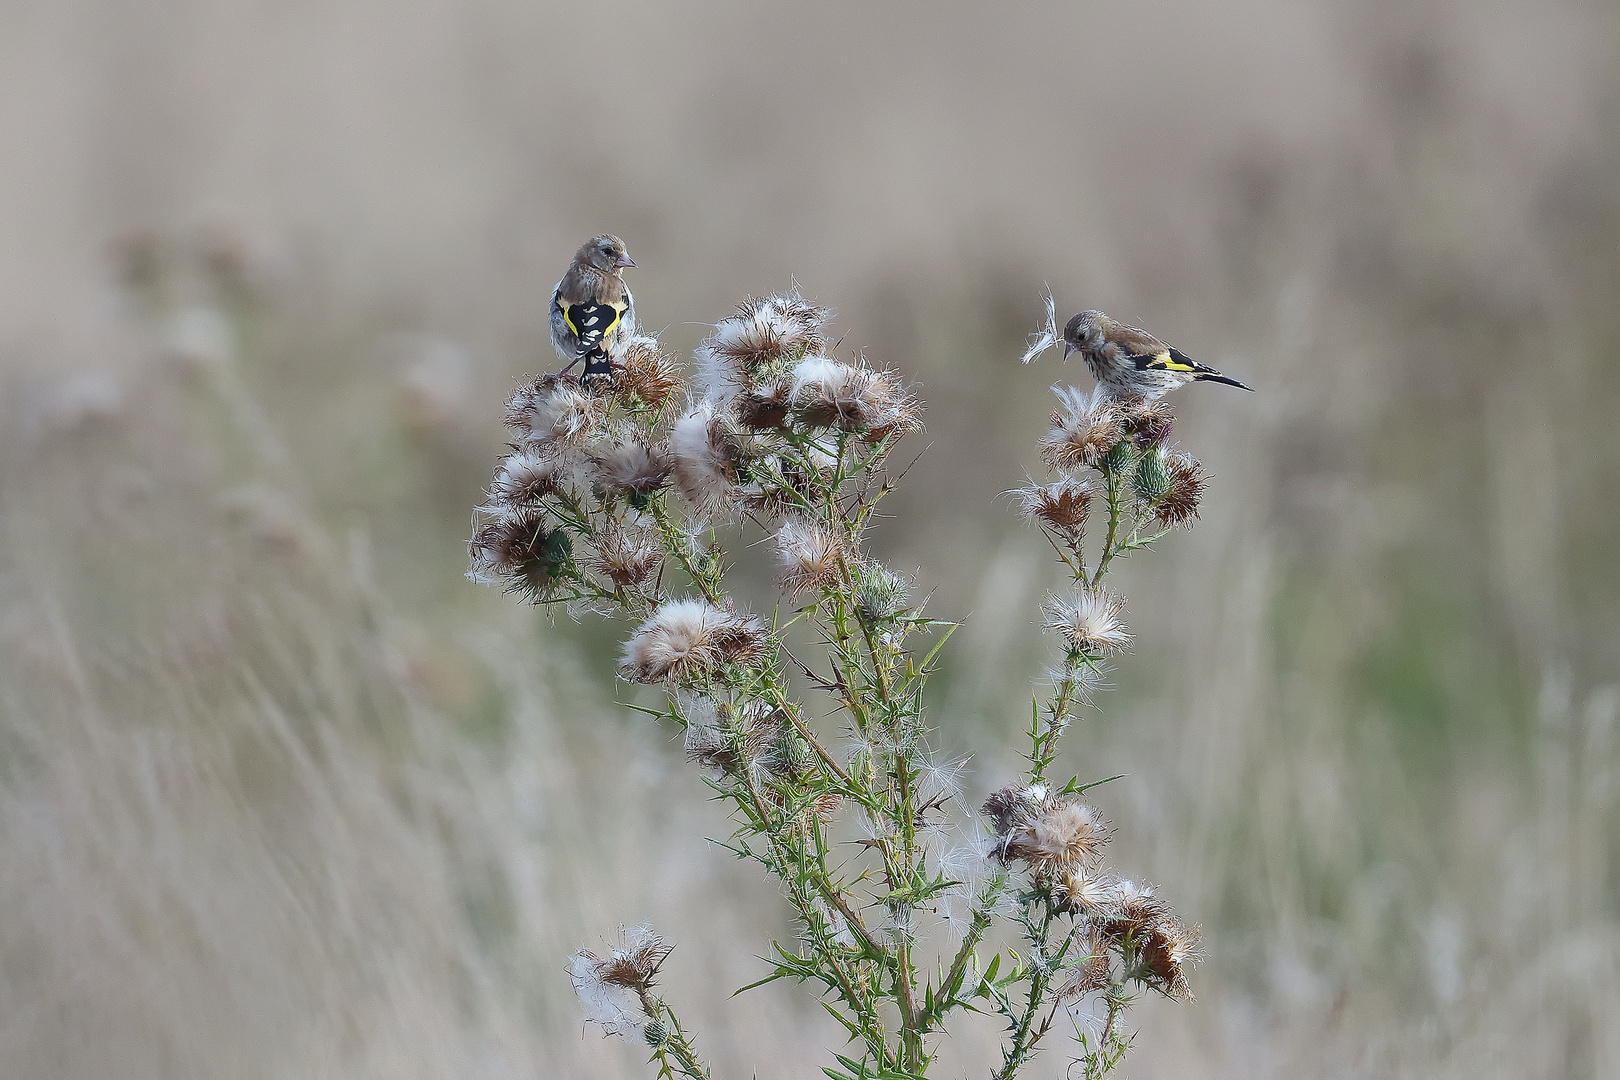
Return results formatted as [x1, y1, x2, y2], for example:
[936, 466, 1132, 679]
[0, 0, 1620, 1080]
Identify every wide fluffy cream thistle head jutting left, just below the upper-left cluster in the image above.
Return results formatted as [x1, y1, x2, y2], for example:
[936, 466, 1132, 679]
[619, 599, 768, 683]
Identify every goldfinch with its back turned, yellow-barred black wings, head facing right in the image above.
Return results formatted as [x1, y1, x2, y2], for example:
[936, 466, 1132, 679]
[551, 235, 635, 381]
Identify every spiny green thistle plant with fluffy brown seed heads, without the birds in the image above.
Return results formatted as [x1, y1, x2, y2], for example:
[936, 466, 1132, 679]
[470, 295, 1204, 1080]
